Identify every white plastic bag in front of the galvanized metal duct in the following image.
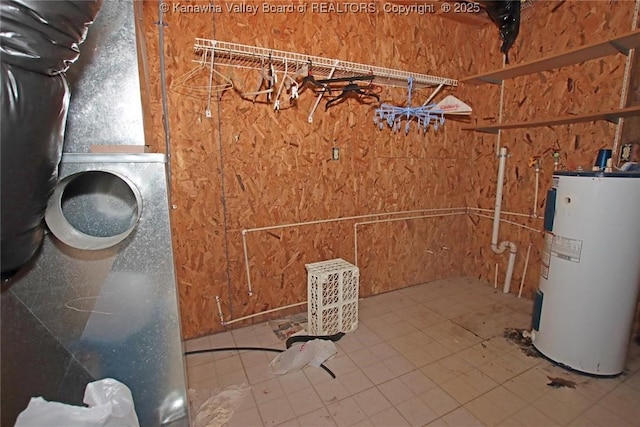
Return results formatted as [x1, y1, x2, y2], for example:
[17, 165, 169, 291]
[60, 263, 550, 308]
[15, 378, 140, 427]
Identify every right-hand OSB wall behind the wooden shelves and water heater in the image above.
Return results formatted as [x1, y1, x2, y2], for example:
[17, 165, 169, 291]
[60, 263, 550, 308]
[465, 1, 635, 304]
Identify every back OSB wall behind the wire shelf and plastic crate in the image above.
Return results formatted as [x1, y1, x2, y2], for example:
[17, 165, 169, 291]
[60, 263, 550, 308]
[144, 2, 497, 338]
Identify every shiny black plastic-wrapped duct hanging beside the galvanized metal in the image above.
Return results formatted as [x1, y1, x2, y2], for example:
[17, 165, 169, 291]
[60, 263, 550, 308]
[0, 0, 102, 281]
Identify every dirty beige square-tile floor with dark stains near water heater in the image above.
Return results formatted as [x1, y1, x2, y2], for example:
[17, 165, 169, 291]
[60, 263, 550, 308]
[185, 278, 640, 427]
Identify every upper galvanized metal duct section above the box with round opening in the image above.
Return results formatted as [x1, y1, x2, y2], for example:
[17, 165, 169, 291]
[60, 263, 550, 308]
[63, 0, 146, 153]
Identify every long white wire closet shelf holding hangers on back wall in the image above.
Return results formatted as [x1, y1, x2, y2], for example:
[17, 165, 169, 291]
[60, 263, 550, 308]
[194, 38, 458, 89]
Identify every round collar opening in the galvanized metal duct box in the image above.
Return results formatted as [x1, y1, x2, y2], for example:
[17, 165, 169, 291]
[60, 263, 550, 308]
[45, 171, 142, 250]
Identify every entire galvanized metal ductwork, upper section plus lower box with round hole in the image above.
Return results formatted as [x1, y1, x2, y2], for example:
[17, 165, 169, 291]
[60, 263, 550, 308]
[0, 0, 189, 427]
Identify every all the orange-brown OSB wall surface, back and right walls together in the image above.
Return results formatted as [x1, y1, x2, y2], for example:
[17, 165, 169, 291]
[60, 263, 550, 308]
[138, 1, 634, 338]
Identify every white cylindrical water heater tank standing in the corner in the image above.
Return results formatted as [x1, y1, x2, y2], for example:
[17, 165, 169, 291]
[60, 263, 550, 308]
[532, 172, 640, 376]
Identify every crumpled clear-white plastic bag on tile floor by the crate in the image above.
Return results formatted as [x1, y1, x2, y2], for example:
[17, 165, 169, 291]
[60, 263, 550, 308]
[269, 339, 338, 374]
